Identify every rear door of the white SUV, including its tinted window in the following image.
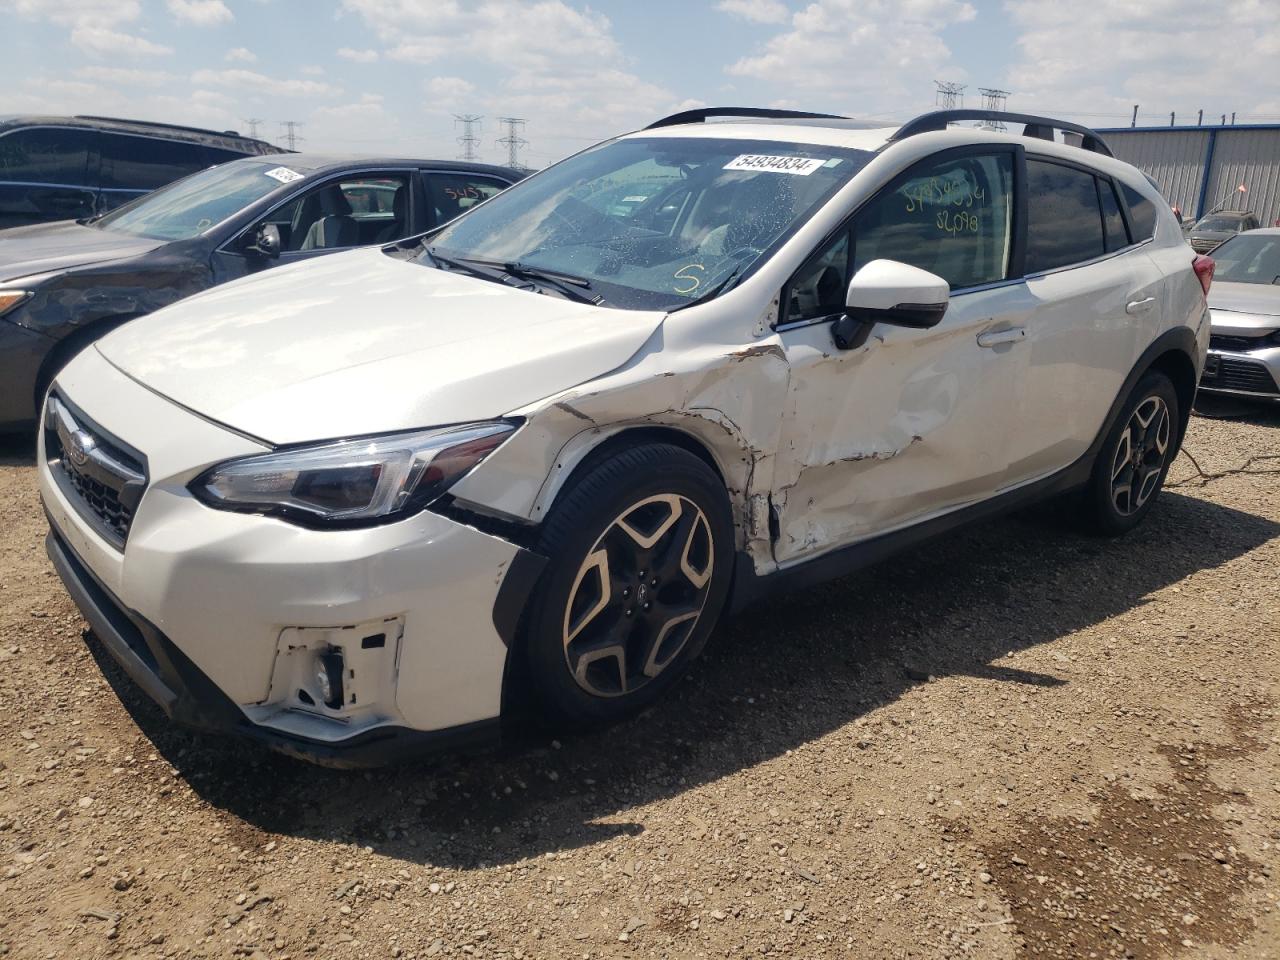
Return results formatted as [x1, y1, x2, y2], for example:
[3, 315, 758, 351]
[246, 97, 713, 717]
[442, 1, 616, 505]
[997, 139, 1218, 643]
[1009, 161, 1162, 484]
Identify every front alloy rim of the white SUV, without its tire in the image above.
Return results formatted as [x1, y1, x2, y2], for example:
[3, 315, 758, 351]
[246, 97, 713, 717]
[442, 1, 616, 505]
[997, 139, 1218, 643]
[563, 494, 716, 696]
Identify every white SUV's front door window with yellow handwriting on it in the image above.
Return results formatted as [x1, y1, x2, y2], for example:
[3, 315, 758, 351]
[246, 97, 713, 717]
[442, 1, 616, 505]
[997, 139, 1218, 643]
[852, 152, 1014, 289]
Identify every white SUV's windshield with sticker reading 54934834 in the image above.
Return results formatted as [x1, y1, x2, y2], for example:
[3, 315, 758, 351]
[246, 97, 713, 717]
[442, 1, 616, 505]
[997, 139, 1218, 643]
[420, 137, 873, 310]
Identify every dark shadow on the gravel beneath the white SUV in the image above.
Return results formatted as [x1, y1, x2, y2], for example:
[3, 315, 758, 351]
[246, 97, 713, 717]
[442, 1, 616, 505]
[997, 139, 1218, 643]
[91, 493, 1280, 869]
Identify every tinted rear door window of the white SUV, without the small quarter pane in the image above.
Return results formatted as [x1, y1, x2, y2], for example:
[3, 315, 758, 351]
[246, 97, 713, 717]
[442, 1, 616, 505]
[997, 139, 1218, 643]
[1027, 159, 1106, 274]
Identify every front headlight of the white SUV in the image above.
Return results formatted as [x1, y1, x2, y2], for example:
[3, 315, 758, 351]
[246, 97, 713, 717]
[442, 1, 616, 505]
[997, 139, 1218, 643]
[188, 420, 520, 526]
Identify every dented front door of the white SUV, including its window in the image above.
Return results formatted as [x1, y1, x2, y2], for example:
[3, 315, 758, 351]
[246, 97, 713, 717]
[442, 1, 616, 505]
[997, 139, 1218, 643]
[772, 146, 1033, 566]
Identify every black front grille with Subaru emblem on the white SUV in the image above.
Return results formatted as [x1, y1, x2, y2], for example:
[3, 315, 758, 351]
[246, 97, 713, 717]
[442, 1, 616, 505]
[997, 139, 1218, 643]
[45, 393, 147, 549]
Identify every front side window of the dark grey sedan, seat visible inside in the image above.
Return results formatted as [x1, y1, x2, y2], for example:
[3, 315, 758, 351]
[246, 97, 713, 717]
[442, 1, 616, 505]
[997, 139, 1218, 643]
[263, 173, 412, 252]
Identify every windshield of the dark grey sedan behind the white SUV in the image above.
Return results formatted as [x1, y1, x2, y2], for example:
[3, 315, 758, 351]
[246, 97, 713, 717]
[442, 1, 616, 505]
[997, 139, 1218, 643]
[93, 160, 300, 241]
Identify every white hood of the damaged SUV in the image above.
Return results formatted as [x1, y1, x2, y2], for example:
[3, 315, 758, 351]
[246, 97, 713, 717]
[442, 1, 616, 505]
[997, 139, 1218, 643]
[97, 250, 666, 444]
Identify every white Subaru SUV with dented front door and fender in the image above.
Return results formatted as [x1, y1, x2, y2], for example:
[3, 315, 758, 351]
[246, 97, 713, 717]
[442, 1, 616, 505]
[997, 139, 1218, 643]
[40, 110, 1212, 763]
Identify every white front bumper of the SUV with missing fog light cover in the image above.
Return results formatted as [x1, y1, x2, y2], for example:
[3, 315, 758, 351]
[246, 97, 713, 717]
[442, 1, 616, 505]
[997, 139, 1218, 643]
[38, 349, 539, 763]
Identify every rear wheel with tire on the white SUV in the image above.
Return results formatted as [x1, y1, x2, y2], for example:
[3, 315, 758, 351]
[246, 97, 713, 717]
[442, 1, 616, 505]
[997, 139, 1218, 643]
[1088, 371, 1181, 536]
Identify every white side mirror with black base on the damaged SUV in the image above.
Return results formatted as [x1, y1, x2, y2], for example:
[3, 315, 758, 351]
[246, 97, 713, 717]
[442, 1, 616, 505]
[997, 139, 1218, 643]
[832, 260, 951, 349]
